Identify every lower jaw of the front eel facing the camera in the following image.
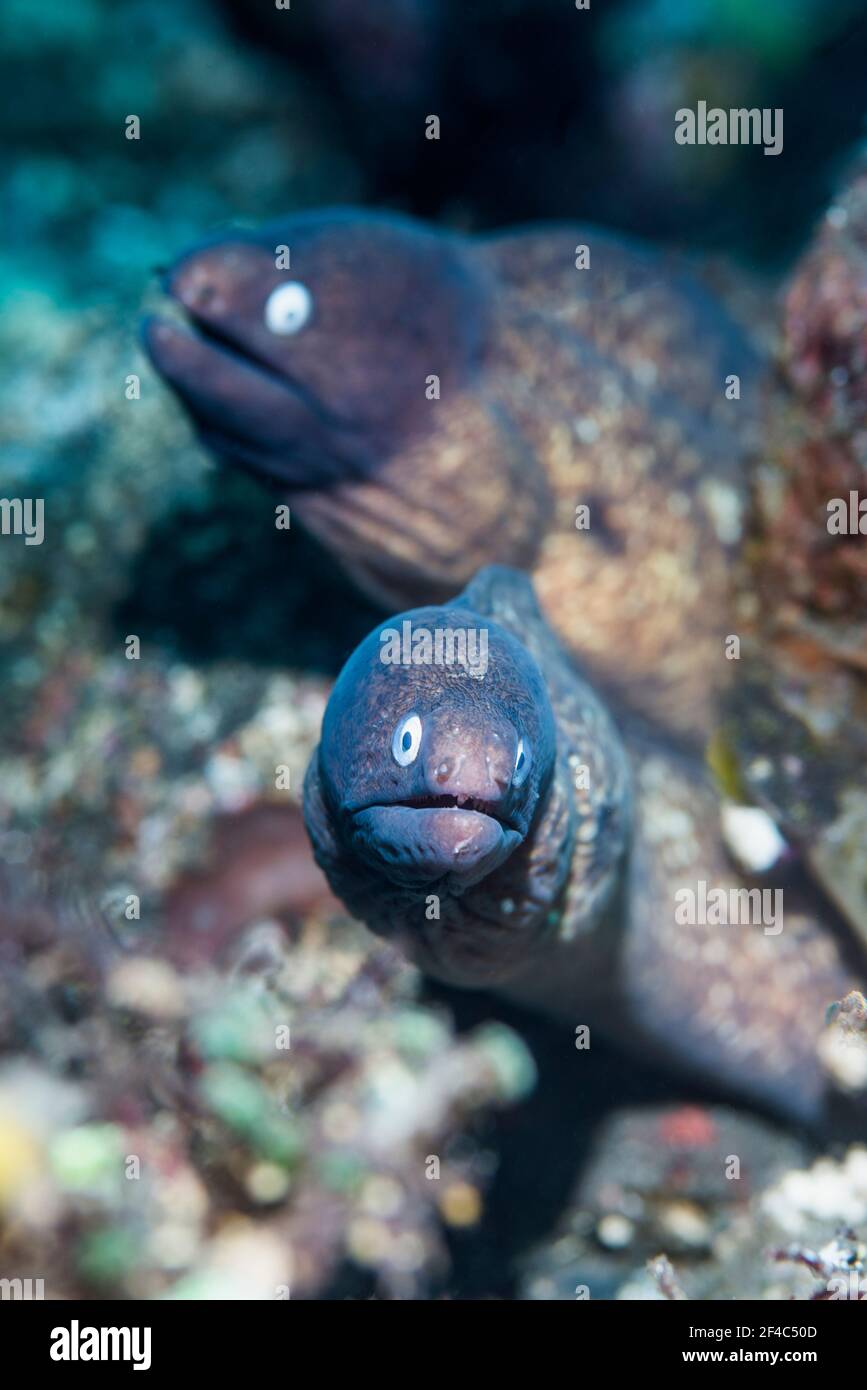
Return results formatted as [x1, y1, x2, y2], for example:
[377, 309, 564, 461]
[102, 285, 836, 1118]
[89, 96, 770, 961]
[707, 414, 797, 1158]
[350, 796, 524, 894]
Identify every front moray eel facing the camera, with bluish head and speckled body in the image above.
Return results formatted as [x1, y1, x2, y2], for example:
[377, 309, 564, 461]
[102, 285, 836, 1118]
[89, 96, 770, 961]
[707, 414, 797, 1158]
[304, 566, 852, 1125]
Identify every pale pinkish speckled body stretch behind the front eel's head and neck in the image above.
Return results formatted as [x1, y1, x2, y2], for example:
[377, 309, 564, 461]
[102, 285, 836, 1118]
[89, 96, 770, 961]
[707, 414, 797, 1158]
[617, 745, 864, 1123]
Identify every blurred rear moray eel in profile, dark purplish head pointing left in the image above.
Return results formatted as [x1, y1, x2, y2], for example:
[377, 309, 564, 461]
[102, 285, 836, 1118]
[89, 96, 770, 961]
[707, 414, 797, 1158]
[145, 209, 761, 744]
